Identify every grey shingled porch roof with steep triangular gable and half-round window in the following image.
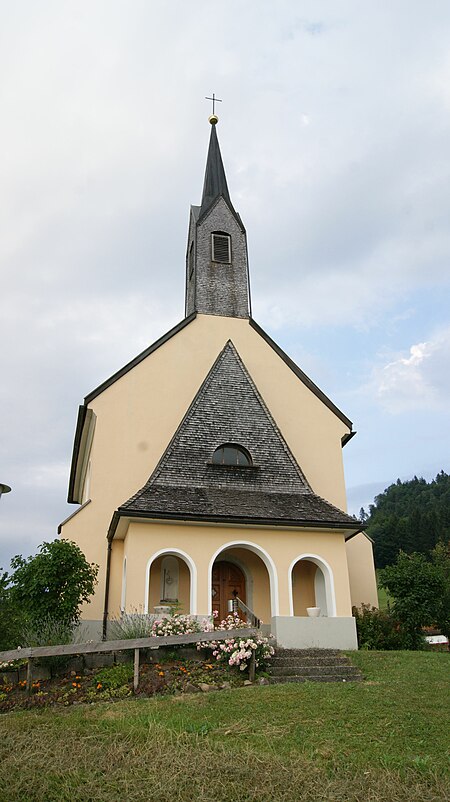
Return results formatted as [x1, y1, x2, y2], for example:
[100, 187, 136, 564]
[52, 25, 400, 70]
[111, 340, 358, 536]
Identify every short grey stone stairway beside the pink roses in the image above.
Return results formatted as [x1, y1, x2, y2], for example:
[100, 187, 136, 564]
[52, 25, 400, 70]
[270, 649, 364, 684]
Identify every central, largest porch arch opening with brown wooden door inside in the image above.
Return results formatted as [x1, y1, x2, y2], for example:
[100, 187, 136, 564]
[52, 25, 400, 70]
[210, 543, 276, 623]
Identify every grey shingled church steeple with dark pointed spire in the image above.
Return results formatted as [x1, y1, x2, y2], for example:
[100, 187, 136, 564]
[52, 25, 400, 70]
[186, 114, 250, 318]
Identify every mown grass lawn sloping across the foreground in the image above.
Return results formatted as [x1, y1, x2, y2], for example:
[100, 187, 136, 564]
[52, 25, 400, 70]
[0, 652, 450, 802]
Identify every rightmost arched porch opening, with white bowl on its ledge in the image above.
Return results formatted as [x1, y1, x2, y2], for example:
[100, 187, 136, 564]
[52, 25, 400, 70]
[290, 555, 335, 617]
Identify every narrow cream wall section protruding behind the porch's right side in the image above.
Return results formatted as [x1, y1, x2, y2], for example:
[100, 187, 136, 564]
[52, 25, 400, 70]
[346, 532, 378, 607]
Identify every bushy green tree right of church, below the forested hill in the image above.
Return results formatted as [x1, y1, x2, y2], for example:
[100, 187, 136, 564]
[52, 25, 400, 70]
[379, 551, 448, 649]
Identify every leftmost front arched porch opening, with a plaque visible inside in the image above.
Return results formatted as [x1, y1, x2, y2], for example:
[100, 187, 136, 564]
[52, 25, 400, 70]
[146, 551, 192, 614]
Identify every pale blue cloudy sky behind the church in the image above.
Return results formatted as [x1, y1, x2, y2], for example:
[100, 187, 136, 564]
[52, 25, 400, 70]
[0, 0, 450, 569]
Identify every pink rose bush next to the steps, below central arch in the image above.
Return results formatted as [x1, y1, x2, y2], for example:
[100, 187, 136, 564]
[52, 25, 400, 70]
[197, 611, 274, 671]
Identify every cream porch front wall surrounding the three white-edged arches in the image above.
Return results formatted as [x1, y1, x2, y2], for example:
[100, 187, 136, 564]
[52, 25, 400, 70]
[116, 522, 351, 621]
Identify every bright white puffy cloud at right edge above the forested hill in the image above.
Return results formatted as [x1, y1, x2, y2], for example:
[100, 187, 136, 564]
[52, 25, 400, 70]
[370, 327, 450, 414]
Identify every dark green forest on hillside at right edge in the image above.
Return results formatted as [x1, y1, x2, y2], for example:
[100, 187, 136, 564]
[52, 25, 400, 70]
[360, 471, 450, 568]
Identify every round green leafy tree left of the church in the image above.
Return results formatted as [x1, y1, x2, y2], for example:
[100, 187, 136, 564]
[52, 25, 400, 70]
[10, 540, 98, 625]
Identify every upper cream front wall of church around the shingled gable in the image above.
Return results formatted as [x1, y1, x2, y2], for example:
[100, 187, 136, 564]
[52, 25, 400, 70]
[62, 315, 348, 619]
